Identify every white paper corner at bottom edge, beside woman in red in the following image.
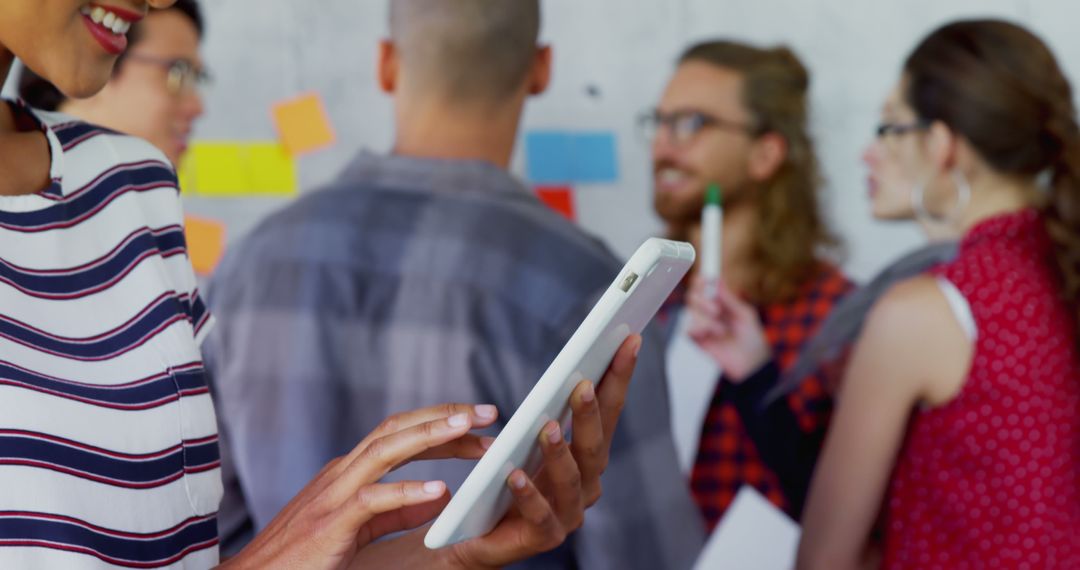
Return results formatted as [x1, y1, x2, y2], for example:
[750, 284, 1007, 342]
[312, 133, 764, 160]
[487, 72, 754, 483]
[694, 485, 801, 570]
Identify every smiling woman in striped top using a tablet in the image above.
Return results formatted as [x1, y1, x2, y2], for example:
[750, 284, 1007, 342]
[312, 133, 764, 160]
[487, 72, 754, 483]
[0, 0, 640, 568]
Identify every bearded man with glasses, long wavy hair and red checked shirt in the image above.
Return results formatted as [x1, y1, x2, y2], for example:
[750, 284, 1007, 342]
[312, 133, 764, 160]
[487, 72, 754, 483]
[642, 41, 851, 529]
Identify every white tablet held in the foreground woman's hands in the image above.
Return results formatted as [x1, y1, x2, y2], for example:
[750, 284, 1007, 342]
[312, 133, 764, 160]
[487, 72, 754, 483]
[423, 239, 694, 548]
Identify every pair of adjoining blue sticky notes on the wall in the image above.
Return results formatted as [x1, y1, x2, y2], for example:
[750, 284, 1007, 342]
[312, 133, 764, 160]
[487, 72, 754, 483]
[525, 131, 619, 185]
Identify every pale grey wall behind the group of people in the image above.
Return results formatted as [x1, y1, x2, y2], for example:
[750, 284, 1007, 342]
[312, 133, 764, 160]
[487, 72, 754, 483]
[10, 0, 1080, 279]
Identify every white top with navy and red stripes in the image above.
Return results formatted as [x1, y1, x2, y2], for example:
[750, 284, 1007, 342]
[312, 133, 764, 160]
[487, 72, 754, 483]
[0, 100, 221, 569]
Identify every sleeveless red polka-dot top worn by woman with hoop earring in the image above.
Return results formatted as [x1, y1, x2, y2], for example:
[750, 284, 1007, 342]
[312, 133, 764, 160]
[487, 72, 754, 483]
[885, 209, 1080, 570]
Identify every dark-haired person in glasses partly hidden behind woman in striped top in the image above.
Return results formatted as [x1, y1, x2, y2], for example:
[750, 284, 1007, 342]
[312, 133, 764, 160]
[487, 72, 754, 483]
[18, 0, 207, 165]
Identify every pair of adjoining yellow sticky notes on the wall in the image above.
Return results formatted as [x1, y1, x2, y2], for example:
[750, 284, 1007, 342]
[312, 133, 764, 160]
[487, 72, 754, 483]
[180, 140, 297, 198]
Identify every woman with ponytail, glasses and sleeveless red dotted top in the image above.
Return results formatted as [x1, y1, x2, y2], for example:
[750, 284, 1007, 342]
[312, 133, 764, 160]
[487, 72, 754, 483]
[798, 21, 1080, 570]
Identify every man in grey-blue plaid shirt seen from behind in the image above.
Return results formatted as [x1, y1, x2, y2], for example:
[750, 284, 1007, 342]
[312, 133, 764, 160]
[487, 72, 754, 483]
[205, 0, 704, 570]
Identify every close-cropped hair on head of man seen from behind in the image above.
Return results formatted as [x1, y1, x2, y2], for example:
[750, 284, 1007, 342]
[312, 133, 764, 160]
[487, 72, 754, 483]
[390, 0, 540, 105]
